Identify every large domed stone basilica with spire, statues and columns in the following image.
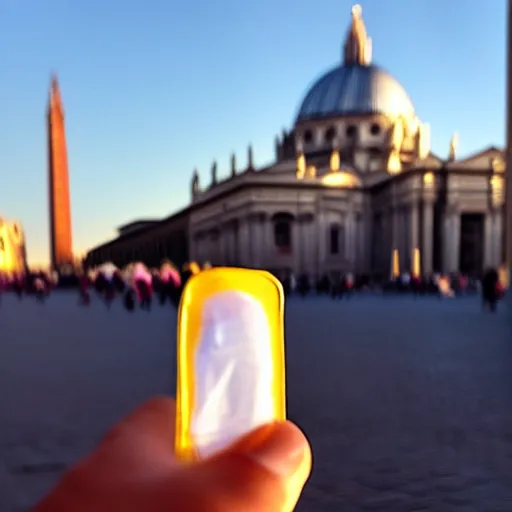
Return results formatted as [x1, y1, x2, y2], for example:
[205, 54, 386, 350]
[87, 6, 505, 278]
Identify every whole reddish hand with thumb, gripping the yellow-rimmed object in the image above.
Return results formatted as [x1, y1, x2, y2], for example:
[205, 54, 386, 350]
[34, 398, 312, 512]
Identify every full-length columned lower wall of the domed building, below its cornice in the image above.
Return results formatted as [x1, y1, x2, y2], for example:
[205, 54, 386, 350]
[87, 199, 504, 278]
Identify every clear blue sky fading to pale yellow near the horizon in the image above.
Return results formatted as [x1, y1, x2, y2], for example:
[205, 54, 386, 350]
[0, 0, 506, 263]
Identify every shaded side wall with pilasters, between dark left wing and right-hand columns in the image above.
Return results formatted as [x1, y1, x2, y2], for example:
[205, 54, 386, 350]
[191, 211, 364, 276]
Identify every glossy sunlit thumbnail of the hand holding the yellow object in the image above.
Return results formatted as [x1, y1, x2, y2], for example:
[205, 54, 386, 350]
[246, 422, 307, 477]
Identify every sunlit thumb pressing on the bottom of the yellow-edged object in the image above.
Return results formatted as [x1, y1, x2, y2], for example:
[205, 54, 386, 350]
[169, 422, 311, 512]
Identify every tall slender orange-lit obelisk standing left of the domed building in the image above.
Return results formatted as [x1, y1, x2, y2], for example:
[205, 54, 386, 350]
[47, 78, 73, 270]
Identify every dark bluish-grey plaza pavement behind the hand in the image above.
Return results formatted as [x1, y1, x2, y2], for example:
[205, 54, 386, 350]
[0, 293, 512, 512]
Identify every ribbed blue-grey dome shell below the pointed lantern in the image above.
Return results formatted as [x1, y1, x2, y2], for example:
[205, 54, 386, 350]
[297, 64, 414, 121]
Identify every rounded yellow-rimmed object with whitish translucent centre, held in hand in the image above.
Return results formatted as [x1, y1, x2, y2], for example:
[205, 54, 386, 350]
[175, 267, 286, 460]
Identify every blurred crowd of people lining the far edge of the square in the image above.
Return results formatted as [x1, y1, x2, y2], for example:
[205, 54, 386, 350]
[0, 261, 506, 311]
